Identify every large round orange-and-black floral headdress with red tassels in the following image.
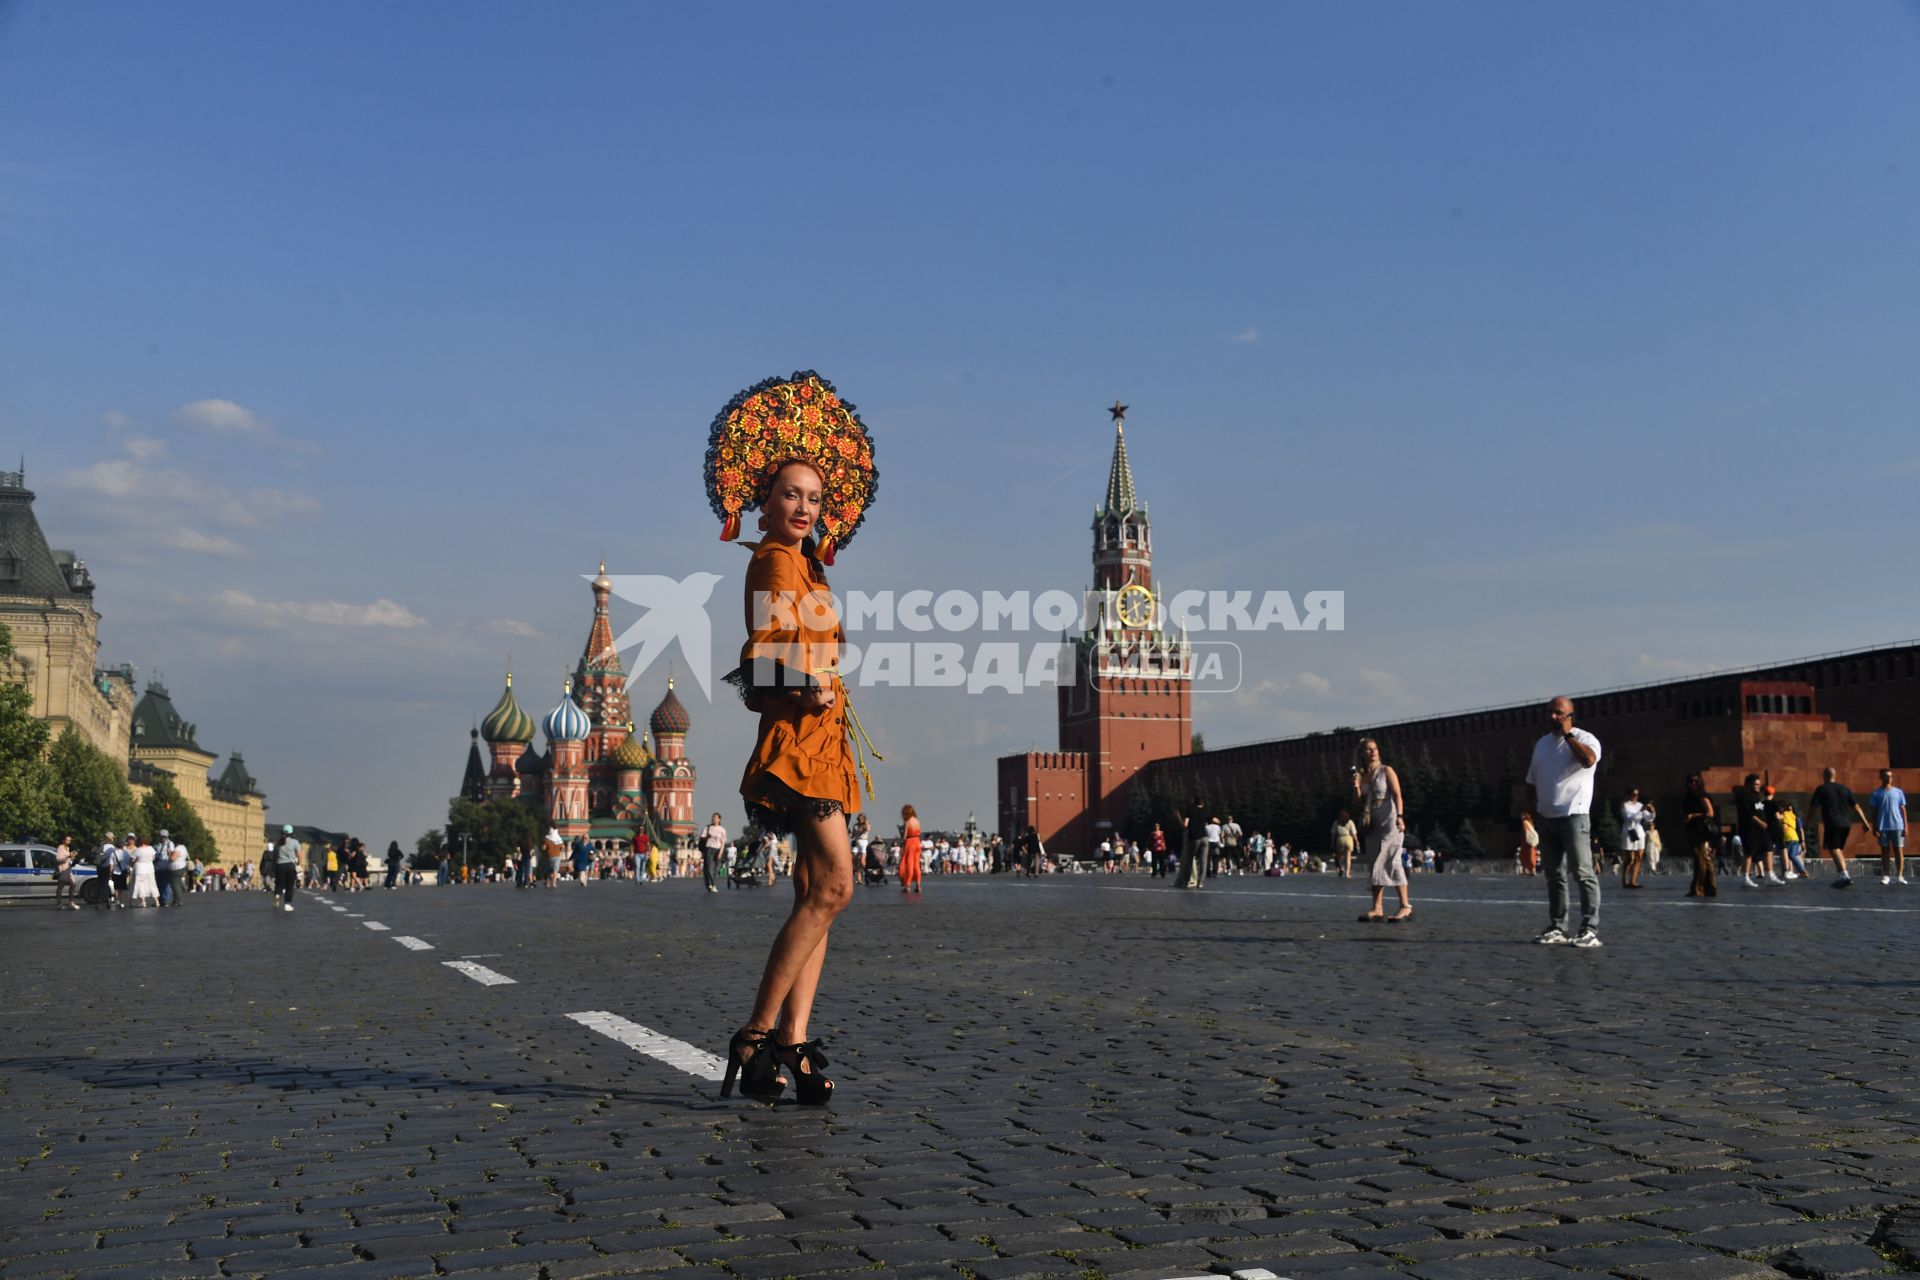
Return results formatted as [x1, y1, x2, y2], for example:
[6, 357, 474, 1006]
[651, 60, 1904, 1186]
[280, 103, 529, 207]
[707, 368, 879, 564]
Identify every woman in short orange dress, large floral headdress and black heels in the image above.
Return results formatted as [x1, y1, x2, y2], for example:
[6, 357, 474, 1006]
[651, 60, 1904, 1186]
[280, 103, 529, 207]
[707, 372, 876, 1105]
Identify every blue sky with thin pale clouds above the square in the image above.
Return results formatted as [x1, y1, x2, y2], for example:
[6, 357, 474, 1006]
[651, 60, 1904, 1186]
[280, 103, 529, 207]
[0, 2, 1920, 841]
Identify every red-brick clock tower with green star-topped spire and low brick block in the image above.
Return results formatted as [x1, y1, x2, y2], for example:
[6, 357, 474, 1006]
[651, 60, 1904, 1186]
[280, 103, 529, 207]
[998, 401, 1192, 858]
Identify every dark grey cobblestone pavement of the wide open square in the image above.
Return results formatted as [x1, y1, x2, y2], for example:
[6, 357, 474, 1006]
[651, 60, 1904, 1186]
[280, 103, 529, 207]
[0, 875, 1920, 1280]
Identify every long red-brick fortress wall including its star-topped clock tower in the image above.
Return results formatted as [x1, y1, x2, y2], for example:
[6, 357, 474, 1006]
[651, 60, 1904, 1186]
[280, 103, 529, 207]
[996, 405, 1920, 858]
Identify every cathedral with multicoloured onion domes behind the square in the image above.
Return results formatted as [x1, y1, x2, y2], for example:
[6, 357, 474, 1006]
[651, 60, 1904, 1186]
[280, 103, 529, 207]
[461, 562, 693, 848]
